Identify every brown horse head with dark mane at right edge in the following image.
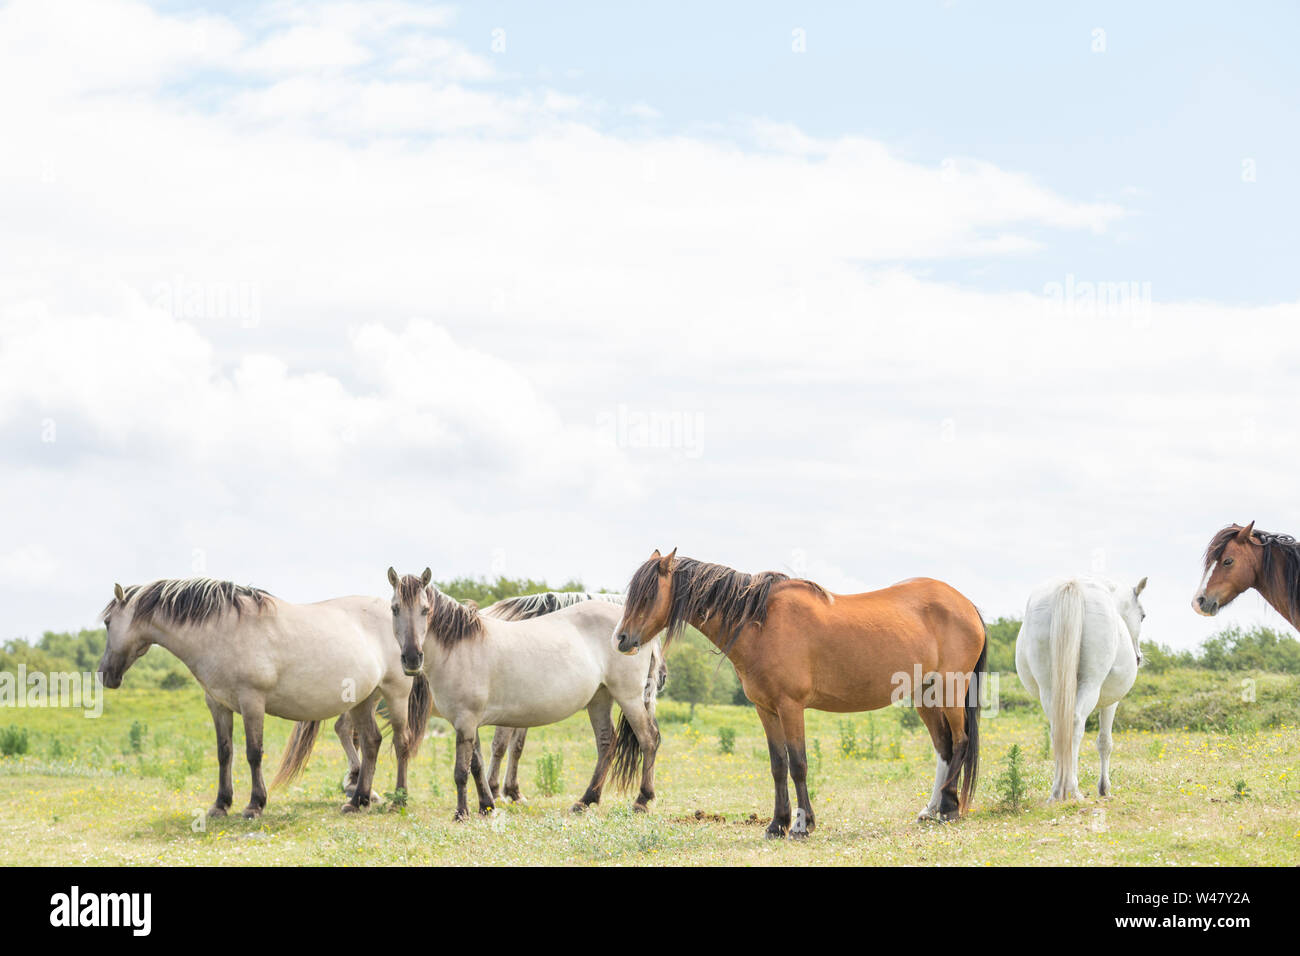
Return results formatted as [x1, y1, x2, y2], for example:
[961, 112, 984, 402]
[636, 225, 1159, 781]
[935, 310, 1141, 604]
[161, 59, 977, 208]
[1192, 522, 1300, 628]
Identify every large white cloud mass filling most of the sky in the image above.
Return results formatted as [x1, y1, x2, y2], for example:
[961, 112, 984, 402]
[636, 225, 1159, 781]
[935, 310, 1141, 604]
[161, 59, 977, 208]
[0, 3, 1300, 655]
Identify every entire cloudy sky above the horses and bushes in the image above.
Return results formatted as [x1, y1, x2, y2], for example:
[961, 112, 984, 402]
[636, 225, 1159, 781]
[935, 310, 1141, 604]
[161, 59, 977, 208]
[0, 0, 1300, 648]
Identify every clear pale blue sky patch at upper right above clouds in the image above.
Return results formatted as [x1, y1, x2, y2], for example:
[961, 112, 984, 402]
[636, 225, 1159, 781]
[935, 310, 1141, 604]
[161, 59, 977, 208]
[455, 3, 1300, 303]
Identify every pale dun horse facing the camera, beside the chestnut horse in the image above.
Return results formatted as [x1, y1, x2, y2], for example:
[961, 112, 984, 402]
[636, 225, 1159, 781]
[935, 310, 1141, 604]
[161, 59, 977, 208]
[389, 568, 663, 821]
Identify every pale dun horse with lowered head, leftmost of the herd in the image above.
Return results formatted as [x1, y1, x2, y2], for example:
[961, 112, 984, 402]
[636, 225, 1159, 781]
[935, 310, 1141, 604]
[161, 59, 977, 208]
[99, 578, 430, 818]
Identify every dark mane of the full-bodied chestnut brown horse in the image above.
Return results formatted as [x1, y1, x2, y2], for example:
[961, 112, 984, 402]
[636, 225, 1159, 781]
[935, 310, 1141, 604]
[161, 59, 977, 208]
[627, 558, 831, 654]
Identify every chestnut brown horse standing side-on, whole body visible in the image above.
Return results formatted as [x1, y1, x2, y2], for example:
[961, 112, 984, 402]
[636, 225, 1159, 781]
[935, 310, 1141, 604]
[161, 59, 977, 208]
[615, 549, 987, 838]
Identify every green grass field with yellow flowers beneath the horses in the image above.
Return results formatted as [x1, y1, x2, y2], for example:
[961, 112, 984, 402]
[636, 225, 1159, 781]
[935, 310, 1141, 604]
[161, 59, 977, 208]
[0, 680, 1300, 866]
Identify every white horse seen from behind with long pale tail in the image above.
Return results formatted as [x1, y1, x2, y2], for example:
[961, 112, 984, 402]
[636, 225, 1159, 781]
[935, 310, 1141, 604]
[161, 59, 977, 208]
[1015, 576, 1147, 801]
